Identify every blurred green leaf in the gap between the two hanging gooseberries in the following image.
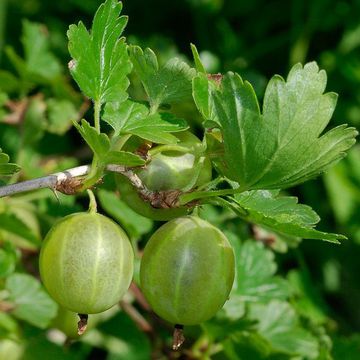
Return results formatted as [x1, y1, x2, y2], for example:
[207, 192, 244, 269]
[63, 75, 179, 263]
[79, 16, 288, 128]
[97, 190, 153, 240]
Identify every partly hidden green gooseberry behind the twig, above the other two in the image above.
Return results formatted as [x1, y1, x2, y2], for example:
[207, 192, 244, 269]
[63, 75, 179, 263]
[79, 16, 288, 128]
[117, 131, 212, 221]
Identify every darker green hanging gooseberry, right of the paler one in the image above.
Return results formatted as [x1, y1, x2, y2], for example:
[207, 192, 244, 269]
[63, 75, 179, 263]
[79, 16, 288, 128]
[140, 216, 235, 325]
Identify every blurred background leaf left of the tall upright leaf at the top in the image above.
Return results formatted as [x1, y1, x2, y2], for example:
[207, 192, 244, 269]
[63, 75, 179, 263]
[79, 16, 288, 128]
[21, 20, 61, 80]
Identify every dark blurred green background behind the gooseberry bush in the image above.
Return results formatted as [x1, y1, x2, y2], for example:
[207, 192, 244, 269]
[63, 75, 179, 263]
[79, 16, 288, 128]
[0, 0, 360, 360]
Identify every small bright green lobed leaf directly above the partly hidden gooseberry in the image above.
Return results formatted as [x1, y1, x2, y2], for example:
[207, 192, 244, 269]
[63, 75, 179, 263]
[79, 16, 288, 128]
[103, 100, 188, 144]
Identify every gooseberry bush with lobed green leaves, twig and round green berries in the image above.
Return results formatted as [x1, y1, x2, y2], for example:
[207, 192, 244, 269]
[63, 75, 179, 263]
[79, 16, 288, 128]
[0, 0, 357, 359]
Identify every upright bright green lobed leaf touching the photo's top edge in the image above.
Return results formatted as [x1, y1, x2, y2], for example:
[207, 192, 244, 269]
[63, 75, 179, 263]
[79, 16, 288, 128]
[67, 0, 131, 104]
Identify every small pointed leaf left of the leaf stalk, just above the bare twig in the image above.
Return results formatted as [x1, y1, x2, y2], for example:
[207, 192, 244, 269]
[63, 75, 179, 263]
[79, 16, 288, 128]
[73, 119, 110, 159]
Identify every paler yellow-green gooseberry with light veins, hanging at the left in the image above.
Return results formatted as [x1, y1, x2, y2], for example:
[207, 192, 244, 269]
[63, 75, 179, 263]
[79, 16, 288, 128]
[39, 213, 134, 314]
